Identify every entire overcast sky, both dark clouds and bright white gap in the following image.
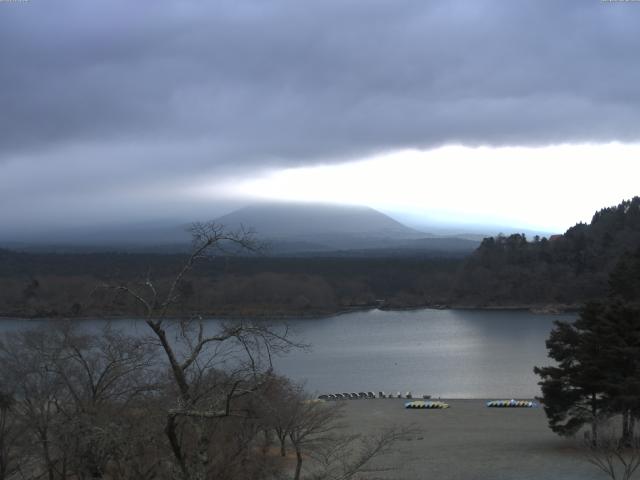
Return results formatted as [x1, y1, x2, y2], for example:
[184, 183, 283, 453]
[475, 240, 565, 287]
[0, 0, 640, 236]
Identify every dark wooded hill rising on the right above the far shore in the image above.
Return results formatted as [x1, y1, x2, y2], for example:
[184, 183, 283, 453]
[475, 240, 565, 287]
[454, 197, 640, 305]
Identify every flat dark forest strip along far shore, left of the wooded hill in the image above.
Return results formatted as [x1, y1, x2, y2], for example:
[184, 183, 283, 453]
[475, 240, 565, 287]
[0, 251, 462, 316]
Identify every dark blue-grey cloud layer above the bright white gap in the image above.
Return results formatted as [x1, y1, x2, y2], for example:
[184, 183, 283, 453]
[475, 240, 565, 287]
[0, 0, 640, 231]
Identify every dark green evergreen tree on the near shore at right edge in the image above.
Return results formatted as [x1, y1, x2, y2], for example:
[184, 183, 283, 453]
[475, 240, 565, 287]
[534, 299, 640, 443]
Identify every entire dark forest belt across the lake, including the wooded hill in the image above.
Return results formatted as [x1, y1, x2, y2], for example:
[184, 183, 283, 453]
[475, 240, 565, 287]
[0, 197, 640, 316]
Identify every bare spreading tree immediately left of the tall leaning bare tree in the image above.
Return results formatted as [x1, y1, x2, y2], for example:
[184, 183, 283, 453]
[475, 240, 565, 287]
[49, 325, 157, 478]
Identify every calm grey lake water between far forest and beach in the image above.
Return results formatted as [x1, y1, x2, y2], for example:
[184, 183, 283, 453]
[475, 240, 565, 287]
[0, 309, 575, 398]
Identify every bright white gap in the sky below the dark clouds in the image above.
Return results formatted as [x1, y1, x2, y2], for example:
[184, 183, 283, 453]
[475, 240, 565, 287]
[217, 143, 640, 231]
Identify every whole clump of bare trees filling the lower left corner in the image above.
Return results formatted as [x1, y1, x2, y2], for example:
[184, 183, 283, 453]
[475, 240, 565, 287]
[0, 322, 156, 480]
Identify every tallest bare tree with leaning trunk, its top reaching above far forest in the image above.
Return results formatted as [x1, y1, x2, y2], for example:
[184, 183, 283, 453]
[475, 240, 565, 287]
[106, 223, 298, 480]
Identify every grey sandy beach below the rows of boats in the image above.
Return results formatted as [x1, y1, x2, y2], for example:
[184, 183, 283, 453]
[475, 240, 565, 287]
[344, 399, 606, 480]
